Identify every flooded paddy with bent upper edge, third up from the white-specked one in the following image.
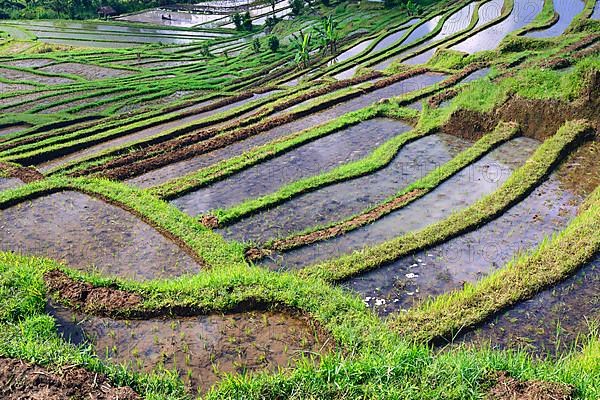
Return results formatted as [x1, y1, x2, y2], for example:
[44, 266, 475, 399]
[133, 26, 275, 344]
[221, 134, 469, 242]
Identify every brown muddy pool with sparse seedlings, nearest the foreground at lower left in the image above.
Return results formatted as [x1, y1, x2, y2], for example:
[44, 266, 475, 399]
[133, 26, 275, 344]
[49, 308, 331, 392]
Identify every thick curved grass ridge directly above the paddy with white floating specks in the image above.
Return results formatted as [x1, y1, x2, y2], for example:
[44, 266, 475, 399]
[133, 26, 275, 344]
[298, 121, 592, 282]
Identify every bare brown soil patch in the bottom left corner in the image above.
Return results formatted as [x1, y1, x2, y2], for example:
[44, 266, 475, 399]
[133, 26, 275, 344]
[0, 358, 141, 400]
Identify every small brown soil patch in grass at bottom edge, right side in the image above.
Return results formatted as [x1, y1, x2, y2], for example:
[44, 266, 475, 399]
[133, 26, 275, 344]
[485, 372, 575, 400]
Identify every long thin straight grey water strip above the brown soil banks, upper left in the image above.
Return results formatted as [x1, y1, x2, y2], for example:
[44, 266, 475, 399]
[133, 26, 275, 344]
[38, 91, 273, 171]
